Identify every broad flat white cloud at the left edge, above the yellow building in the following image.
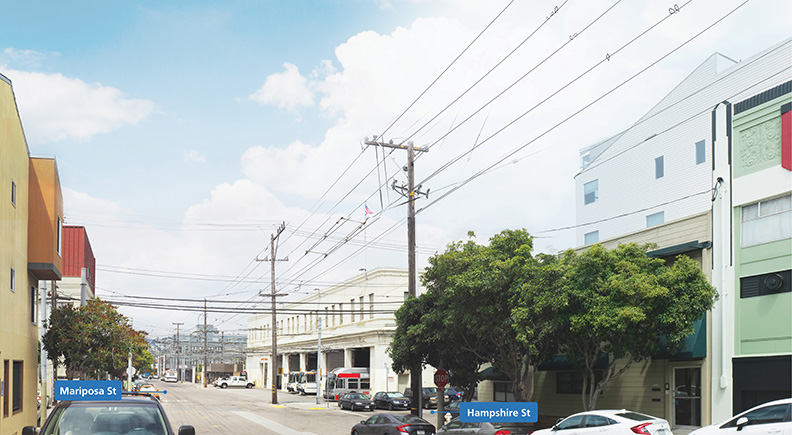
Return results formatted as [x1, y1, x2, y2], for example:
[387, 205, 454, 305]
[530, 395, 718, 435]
[5, 70, 155, 143]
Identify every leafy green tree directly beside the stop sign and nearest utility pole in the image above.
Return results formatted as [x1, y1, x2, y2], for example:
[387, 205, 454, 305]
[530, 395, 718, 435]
[389, 230, 552, 401]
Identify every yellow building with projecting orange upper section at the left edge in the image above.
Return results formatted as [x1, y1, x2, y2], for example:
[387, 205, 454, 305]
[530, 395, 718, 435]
[0, 74, 63, 435]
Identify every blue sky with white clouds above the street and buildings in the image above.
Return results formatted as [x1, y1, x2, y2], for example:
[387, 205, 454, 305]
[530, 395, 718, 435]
[0, 0, 792, 337]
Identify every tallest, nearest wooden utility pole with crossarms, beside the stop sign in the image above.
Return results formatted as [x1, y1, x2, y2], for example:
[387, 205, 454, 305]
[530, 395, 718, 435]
[365, 136, 429, 417]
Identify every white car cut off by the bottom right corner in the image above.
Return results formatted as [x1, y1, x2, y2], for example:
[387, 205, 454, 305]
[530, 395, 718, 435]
[690, 398, 792, 435]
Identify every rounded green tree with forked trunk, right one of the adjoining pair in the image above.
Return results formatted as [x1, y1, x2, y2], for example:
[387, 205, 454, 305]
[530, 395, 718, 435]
[518, 244, 717, 410]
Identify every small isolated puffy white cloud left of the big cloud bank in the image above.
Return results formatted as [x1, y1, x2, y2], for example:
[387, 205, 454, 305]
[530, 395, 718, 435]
[248, 62, 314, 113]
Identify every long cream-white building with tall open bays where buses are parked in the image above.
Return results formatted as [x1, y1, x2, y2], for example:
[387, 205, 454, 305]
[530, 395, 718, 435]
[246, 268, 432, 392]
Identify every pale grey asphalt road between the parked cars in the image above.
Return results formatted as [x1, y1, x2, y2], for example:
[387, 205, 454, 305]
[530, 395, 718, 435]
[154, 381, 414, 435]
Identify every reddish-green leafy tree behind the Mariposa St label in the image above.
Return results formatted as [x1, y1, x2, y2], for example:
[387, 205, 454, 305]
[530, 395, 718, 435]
[42, 299, 153, 379]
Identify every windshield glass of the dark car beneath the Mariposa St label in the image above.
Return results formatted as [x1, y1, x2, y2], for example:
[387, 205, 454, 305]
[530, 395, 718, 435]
[40, 402, 168, 435]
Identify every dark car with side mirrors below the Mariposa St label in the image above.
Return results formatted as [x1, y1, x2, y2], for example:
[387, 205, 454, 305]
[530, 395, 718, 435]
[22, 395, 195, 435]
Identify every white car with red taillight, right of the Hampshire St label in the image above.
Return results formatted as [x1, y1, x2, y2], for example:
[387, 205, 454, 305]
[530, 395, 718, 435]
[533, 409, 673, 435]
